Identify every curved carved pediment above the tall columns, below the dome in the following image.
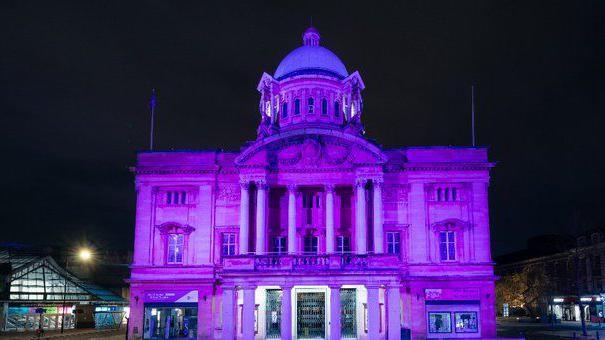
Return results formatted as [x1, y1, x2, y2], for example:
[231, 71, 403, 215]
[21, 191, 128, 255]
[236, 131, 386, 170]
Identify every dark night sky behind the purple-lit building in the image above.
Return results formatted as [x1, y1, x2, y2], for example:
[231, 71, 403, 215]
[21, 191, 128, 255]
[0, 0, 605, 254]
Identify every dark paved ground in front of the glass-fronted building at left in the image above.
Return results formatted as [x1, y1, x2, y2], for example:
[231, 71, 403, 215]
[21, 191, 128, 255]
[0, 329, 125, 340]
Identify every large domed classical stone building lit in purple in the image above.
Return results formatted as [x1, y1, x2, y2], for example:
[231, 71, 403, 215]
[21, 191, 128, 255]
[129, 28, 496, 339]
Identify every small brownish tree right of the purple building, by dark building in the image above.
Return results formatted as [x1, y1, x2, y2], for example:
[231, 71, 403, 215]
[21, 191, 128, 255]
[496, 265, 551, 317]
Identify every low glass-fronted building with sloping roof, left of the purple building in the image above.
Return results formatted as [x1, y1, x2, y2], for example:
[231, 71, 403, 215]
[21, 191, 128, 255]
[0, 248, 128, 332]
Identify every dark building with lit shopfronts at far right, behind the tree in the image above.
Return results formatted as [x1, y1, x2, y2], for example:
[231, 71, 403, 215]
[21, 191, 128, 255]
[496, 228, 605, 323]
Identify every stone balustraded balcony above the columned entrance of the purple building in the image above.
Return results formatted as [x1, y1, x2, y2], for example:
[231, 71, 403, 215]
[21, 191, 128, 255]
[223, 254, 403, 272]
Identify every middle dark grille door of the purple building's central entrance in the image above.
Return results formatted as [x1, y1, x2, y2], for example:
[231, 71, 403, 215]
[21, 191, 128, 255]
[296, 292, 326, 339]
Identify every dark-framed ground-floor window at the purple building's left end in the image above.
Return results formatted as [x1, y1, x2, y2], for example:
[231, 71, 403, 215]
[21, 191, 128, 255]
[143, 304, 197, 339]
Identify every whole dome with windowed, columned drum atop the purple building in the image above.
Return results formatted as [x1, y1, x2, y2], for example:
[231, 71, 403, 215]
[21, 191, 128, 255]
[257, 27, 365, 138]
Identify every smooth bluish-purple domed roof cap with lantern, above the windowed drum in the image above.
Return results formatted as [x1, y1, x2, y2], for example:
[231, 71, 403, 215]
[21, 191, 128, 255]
[273, 27, 349, 80]
